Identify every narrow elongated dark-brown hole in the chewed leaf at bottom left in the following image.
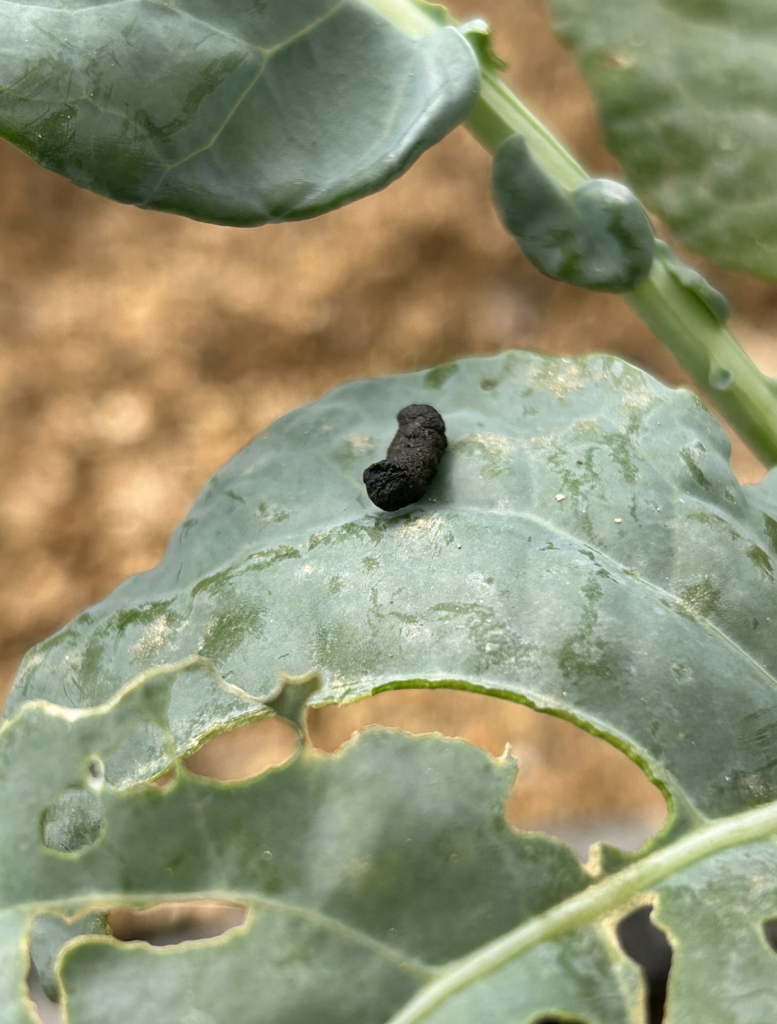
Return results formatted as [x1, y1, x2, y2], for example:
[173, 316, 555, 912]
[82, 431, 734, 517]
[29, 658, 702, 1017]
[109, 900, 248, 946]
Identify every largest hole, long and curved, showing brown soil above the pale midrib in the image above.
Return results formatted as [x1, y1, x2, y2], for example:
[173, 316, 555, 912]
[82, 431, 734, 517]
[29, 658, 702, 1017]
[308, 689, 666, 860]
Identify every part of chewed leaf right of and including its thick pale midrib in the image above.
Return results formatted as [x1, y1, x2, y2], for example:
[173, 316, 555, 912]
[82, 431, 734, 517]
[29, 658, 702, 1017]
[391, 805, 777, 1024]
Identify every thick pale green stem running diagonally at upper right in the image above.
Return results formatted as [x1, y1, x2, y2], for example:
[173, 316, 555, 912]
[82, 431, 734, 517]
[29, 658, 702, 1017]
[466, 70, 777, 466]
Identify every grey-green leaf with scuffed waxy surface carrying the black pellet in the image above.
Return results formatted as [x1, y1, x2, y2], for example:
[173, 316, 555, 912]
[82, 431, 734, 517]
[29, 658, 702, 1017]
[6, 352, 777, 829]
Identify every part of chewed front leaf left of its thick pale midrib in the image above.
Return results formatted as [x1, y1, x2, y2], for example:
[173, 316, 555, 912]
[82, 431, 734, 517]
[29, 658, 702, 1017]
[0, 675, 606, 1024]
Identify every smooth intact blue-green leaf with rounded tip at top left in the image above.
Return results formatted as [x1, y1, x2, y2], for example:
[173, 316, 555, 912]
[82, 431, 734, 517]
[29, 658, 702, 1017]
[0, 0, 479, 224]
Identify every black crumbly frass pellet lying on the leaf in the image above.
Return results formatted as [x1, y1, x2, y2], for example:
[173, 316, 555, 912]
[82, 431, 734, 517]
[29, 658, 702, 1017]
[363, 406, 447, 512]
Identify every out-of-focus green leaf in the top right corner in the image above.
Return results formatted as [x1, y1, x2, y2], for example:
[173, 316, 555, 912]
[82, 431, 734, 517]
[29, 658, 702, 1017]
[549, 0, 777, 279]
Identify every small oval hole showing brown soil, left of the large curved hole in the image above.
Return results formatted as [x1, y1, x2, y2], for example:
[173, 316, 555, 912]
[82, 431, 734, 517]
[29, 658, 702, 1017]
[186, 718, 297, 782]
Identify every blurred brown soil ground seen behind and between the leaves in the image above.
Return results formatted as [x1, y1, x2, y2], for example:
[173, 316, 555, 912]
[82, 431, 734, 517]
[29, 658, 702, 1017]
[0, 0, 777, 824]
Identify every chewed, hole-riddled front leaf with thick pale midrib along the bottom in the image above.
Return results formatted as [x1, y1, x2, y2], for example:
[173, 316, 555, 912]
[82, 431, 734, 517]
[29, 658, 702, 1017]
[0, 673, 777, 1024]
